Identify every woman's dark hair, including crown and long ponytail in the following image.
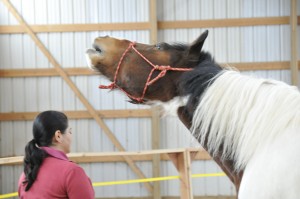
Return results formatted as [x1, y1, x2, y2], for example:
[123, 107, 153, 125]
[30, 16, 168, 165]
[23, 111, 68, 191]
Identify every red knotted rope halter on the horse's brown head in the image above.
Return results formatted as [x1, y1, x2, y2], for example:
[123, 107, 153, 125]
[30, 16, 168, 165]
[99, 42, 192, 103]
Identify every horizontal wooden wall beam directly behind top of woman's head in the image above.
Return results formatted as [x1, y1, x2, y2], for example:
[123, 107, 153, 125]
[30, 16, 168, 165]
[0, 109, 152, 121]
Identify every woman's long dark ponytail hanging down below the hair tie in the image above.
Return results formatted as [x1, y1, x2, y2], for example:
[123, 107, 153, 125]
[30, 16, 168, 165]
[23, 139, 47, 191]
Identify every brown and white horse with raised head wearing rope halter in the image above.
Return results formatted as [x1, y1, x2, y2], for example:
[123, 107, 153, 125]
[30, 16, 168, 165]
[86, 31, 300, 199]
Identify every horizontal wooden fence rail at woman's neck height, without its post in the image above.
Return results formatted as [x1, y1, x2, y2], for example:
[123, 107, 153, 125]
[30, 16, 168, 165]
[0, 149, 212, 166]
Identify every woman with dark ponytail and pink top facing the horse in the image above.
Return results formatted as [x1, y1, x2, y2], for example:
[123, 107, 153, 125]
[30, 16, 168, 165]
[18, 111, 95, 199]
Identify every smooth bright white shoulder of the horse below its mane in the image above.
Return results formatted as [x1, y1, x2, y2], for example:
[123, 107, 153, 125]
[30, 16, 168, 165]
[239, 129, 300, 199]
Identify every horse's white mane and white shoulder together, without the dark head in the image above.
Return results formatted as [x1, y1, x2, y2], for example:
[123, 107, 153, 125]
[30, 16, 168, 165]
[191, 70, 300, 199]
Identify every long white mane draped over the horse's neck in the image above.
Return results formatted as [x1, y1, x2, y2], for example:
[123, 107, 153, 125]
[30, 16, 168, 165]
[191, 70, 300, 170]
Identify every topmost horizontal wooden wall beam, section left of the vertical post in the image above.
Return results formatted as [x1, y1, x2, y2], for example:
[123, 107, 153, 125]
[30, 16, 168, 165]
[0, 22, 151, 34]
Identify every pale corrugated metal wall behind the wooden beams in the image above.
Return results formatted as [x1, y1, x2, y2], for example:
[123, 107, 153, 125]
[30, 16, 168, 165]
[0, 0, 300, 197]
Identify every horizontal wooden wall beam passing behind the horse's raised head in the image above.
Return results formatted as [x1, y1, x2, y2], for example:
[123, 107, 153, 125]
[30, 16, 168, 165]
[0, 61, 300, 77]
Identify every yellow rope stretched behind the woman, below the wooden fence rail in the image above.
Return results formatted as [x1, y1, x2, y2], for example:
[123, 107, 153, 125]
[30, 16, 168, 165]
[0, 173, 225, 199]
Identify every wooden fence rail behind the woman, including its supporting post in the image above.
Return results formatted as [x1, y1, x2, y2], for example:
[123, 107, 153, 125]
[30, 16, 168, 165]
[0, 149, 210, 199]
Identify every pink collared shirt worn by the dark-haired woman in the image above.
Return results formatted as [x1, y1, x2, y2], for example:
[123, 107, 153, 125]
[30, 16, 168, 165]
[18, 147, 95, 199]
